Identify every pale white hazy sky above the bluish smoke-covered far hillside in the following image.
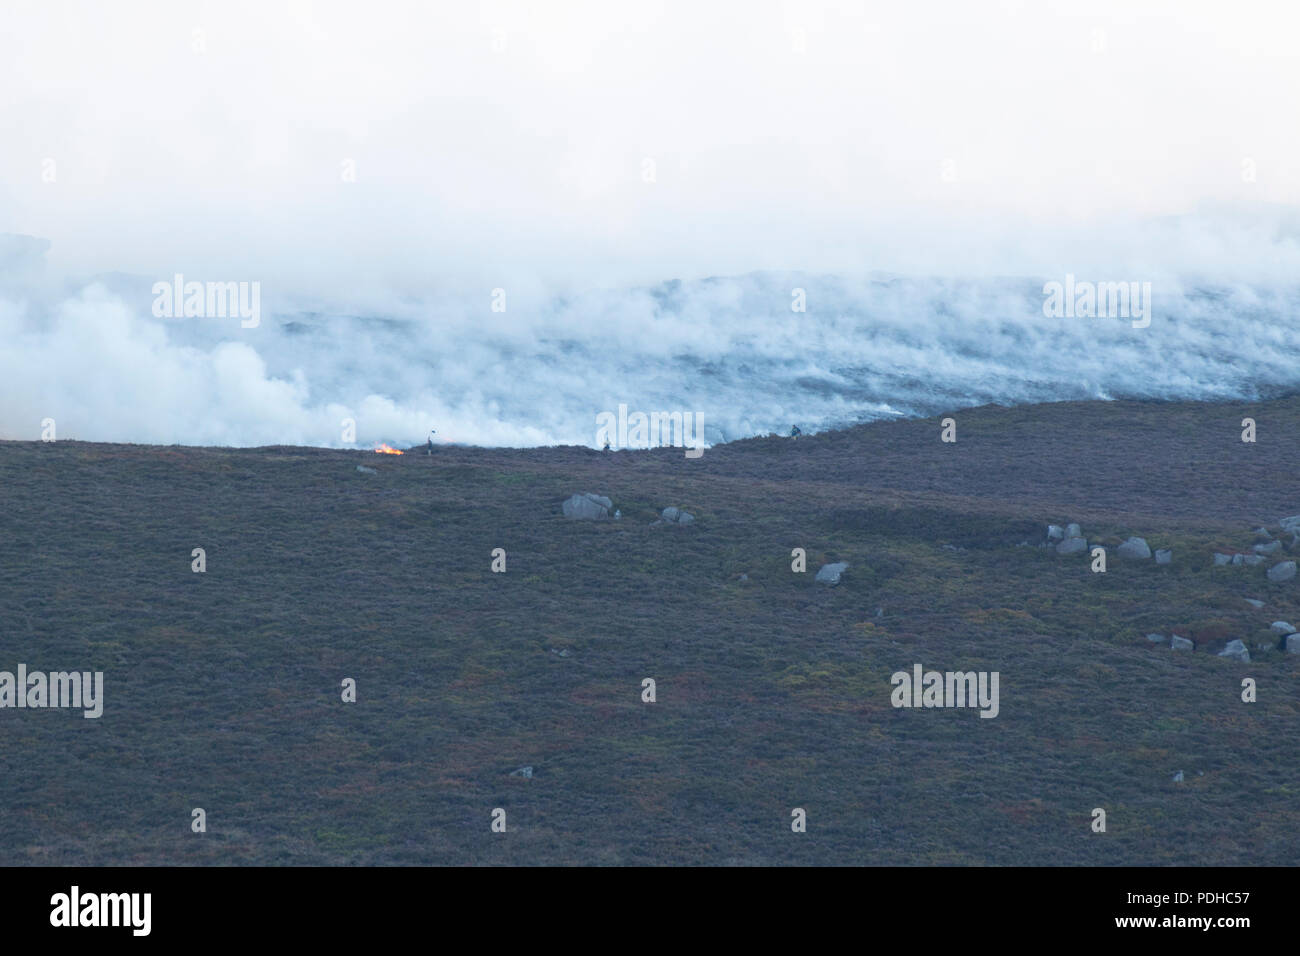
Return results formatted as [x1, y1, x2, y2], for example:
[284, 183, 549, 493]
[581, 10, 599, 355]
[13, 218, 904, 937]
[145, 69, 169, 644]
[0, 0, 1300, 290]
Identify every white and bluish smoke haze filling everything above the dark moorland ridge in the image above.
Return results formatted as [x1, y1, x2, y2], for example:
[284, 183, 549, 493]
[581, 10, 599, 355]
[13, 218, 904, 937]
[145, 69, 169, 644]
[0, 0, 1300, 446]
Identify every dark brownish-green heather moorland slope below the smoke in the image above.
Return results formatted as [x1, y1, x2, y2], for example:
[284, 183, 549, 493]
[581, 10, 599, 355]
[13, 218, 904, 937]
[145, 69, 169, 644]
[0, 398, 1300, 865]
